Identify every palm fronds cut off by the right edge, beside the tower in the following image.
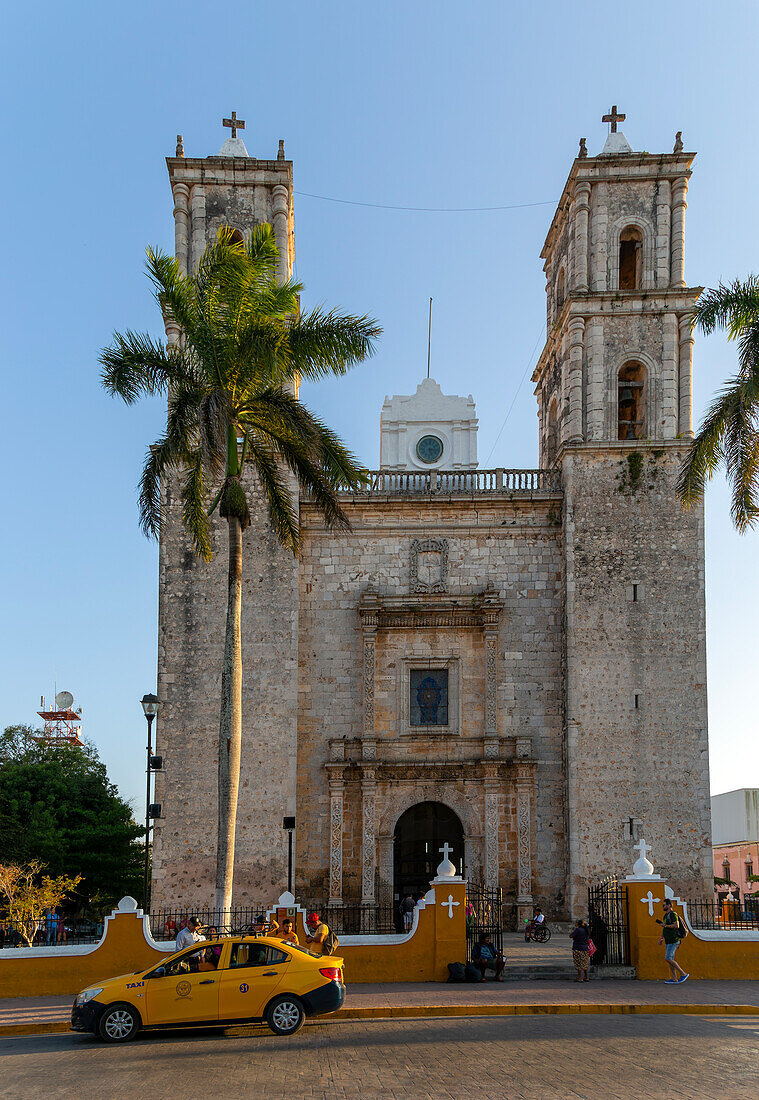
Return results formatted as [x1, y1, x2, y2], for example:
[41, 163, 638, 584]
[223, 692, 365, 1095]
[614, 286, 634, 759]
[678, 275, 759, 532]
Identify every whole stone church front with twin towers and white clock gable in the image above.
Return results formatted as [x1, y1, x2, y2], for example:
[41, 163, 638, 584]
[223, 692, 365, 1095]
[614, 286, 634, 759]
[152, 110, 712, 921]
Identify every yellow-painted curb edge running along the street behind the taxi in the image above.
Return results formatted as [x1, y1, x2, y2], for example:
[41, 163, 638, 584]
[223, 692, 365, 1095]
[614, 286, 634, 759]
[0, 1003, 759, 1038]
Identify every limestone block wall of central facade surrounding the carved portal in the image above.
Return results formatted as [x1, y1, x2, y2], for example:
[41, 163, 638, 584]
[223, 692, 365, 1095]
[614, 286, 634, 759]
[296, 497, 567, 911]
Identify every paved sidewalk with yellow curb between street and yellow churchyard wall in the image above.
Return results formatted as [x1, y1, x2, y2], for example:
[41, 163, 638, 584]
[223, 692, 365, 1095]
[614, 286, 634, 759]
[0, 979, 759, 1036]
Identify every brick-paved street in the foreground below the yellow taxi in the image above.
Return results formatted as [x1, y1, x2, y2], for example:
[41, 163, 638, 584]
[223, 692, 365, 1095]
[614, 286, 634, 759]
[0, 1015, 759, 1100]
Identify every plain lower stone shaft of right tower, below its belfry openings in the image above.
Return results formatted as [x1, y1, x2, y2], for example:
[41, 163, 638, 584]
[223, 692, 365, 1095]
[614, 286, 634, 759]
[563, 441, 712, 912]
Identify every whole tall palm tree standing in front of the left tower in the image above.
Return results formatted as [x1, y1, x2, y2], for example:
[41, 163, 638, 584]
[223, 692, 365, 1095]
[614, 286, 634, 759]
[100, 226, 381, 910]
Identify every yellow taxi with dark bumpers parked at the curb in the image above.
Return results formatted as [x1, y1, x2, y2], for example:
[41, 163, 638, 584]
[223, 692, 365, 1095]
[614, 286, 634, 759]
[72, 936, 345, 1043]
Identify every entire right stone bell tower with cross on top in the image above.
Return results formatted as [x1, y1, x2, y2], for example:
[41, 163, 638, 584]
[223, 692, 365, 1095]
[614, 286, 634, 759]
[534, 107, 711, 912]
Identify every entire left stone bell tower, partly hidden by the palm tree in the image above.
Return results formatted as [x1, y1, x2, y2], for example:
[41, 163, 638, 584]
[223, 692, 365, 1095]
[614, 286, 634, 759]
[152, 118, 298, 909]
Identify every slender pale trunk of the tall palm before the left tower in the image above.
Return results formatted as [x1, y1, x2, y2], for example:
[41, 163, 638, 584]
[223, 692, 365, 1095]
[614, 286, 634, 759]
[213, 516, 242, 910]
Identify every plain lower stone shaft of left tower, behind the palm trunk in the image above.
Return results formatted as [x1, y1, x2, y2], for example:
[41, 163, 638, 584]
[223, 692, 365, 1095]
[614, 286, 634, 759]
[152, 469, 297, 909]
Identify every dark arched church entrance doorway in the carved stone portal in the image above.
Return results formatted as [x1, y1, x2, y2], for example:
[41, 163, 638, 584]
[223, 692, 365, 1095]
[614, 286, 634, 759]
[393, 802, 464, 909]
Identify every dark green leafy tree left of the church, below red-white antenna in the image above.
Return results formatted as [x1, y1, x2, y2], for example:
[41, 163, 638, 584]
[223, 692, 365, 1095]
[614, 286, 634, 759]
[0, 726, 144, 908]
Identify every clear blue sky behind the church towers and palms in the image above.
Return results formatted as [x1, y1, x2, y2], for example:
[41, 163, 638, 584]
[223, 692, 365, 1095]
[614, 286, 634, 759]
[0, 0, 759, 815]
